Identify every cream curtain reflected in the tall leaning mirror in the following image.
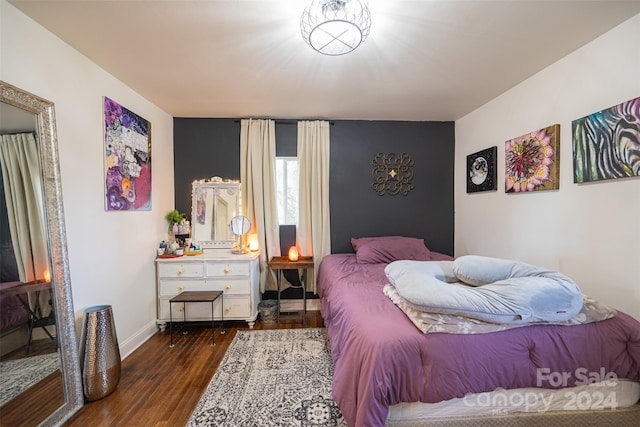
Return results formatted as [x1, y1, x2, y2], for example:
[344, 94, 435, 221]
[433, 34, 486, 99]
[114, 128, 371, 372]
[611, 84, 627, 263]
[0, 133, 50, 316]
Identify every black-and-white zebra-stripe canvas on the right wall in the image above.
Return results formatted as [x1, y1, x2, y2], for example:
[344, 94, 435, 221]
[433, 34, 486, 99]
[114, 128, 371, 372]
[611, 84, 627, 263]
[571, 98, 640, 183]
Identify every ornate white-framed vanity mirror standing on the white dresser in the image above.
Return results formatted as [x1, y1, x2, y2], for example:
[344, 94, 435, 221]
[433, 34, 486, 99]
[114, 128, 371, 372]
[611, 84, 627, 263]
[191, 176, 240, 248]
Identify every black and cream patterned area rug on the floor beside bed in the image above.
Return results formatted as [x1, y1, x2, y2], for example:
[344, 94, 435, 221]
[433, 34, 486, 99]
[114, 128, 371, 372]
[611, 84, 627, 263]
[187, 328, 347, 427]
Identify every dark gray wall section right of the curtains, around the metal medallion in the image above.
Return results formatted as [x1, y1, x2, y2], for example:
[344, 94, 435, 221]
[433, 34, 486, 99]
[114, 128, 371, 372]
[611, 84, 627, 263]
[329, 121, 455, 255]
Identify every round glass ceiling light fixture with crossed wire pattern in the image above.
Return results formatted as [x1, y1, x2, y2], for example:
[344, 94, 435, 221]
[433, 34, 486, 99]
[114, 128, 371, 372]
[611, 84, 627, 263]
[300, 0, 371, 56]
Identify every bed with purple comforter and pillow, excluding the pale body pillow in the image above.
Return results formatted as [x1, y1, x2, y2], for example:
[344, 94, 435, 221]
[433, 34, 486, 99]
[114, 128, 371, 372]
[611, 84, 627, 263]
[318, 239, 640, 427]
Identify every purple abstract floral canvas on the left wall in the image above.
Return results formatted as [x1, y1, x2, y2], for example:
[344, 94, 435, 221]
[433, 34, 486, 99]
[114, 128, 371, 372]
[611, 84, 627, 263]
[103, 96, 151, 211]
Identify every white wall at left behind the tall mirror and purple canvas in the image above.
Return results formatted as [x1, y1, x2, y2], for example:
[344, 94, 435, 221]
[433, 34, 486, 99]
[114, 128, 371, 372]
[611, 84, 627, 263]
[0, 0, 174, 356]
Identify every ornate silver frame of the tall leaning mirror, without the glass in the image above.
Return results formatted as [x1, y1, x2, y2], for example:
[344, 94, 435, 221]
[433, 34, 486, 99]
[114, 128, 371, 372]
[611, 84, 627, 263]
[0, 81, 84, 426]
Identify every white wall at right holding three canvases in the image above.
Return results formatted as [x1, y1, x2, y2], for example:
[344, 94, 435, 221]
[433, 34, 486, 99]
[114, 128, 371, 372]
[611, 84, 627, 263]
[455, 15, 640, 318]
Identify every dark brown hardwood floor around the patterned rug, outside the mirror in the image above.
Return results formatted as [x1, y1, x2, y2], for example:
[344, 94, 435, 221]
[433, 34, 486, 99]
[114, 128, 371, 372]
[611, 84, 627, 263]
[53, 311, 323, 427]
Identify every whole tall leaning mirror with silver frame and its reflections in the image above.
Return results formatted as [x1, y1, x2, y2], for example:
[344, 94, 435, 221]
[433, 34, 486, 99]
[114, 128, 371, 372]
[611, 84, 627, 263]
[0, 81, 83, 426]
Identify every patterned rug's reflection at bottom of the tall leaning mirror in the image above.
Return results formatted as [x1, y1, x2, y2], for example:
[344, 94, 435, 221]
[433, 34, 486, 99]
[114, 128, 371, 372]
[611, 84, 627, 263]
[0, 352, 60, 406]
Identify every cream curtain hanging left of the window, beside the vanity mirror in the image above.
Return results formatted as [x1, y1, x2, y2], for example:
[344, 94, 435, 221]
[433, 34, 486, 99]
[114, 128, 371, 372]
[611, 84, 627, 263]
[240, 119, 280, 292]
